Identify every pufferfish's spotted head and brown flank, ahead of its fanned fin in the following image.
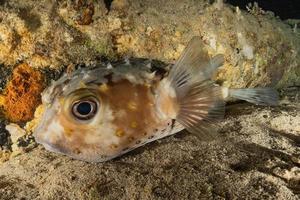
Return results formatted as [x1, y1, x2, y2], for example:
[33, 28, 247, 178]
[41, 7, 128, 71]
[34, 67, 161, 162]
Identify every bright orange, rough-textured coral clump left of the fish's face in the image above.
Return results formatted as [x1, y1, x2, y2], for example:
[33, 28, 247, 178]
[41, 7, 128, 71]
[3, 64, 44, 122]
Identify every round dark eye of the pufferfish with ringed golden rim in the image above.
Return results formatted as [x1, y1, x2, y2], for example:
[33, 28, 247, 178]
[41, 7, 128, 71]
[72, 99, 98, 120]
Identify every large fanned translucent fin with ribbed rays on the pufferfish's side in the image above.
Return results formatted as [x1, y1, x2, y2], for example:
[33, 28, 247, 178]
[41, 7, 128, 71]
[167, 37, 224, 139]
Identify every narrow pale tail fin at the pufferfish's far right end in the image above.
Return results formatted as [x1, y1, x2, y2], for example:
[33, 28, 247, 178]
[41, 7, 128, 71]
[229, 88, 279, 106]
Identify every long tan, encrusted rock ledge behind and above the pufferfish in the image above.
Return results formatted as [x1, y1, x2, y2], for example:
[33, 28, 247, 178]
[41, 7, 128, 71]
[0, 0, 300, 88]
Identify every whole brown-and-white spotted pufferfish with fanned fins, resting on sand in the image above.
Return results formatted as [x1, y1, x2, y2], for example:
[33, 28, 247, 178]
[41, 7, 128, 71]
[34, 37, 278, 162]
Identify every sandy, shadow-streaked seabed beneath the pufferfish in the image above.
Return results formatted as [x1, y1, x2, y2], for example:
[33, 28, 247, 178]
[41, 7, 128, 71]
[0, 90, 300, 200]
